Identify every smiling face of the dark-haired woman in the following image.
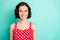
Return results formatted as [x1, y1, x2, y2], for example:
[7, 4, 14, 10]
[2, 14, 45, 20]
[19, 5, 28, 20]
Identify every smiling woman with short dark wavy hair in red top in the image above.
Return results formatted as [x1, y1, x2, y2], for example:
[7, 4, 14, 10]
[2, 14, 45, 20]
[10, 2, 36, 40]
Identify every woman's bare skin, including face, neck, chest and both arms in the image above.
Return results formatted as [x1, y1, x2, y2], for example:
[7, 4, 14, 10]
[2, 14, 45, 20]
[10, 5, 36, 40]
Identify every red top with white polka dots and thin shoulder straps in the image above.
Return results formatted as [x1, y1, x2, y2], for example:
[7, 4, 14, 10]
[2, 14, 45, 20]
[13, 22, 34, 40]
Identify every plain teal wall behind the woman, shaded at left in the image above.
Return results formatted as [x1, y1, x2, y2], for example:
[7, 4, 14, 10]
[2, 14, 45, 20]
[0, 0, 60, 40]
